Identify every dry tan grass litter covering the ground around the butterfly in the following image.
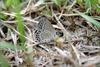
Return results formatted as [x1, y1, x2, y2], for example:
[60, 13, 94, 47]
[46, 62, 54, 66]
[0, 0, 100, 67]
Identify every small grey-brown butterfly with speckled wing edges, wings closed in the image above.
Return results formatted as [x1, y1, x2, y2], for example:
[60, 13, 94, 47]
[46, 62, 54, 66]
[35, 16, 57, 42]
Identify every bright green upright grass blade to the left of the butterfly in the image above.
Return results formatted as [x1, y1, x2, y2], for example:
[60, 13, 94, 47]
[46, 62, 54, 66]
[14, 0, 25, 46]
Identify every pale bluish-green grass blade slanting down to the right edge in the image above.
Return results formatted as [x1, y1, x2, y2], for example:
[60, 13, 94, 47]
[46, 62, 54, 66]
[78, 12, 100, 27]
